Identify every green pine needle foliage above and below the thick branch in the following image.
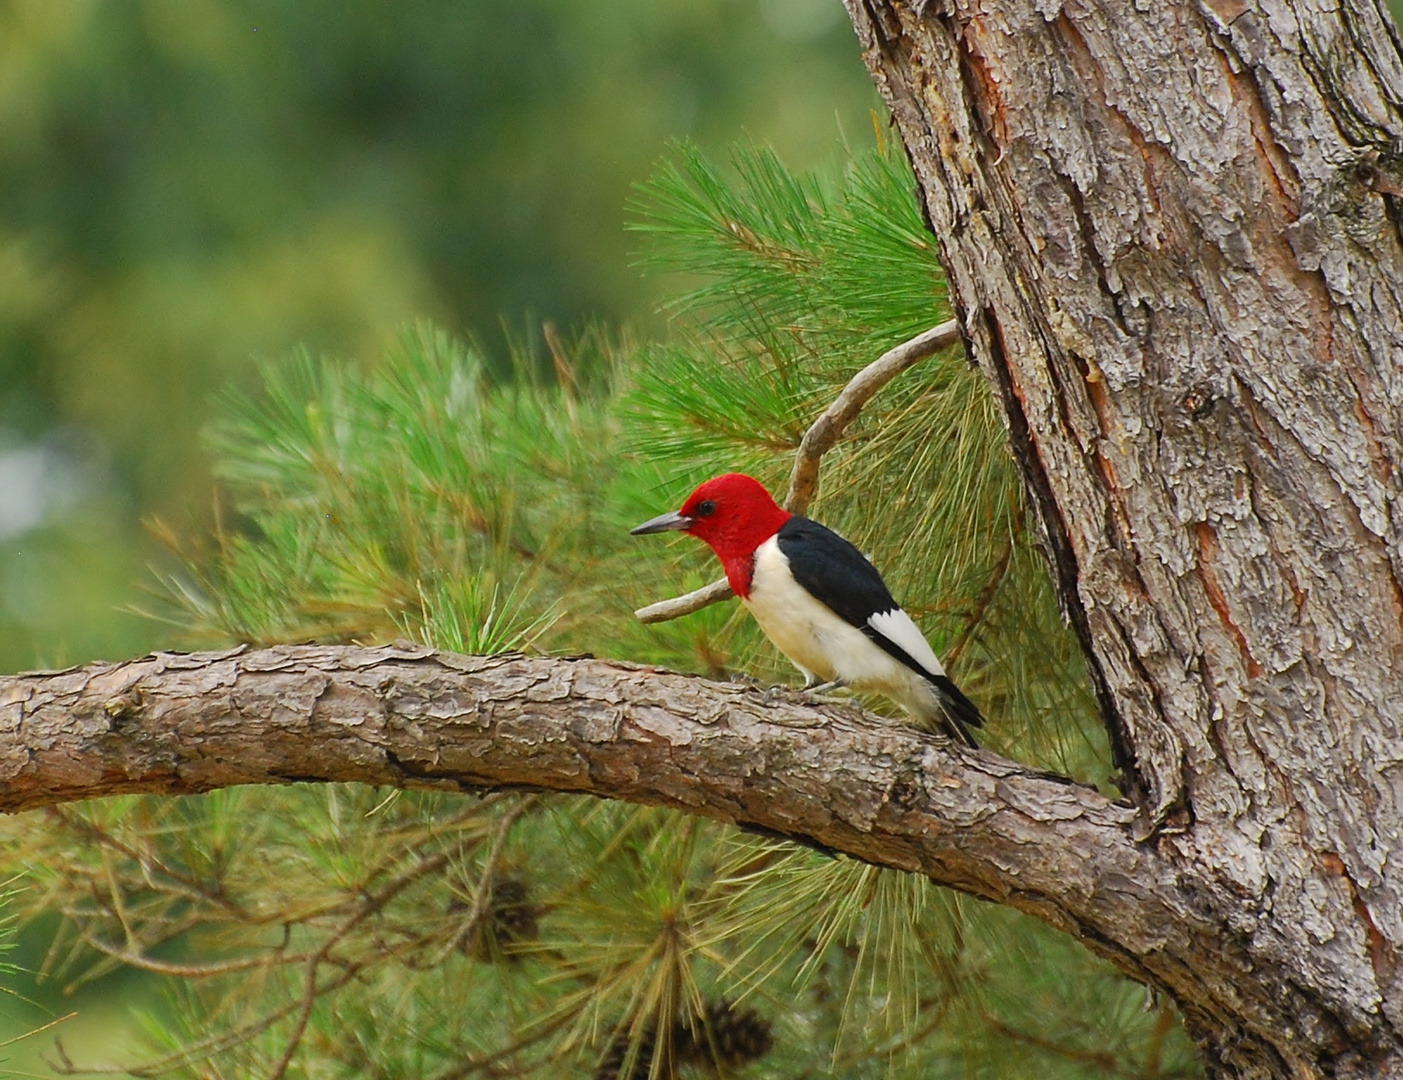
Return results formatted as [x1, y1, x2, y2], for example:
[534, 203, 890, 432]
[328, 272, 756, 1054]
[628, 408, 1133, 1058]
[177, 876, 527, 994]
[10, 146, 1195, 1080]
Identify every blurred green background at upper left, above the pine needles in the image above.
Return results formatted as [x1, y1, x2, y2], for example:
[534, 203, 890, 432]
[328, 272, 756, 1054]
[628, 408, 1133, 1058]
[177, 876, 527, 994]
[0, 0, 877, 670]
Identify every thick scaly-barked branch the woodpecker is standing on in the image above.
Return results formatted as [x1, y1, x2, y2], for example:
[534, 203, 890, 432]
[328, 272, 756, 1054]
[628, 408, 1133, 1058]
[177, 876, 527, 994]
[0, 645, 1229, 998]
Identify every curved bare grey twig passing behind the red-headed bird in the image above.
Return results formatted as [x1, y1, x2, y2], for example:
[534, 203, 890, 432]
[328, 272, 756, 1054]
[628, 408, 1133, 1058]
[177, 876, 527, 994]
[634, 318, 960, 623]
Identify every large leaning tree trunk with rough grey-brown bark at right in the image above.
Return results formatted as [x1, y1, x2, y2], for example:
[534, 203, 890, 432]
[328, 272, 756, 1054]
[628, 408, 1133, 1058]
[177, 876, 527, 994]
[847, 0, 1403, 1077]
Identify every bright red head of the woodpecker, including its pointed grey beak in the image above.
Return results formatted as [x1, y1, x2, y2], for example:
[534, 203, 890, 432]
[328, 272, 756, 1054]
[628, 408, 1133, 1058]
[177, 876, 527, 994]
[633, 473, 793, 596]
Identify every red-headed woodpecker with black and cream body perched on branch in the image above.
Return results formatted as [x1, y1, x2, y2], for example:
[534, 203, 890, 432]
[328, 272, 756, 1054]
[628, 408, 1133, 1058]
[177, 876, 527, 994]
[630, 473, 984, 748]
